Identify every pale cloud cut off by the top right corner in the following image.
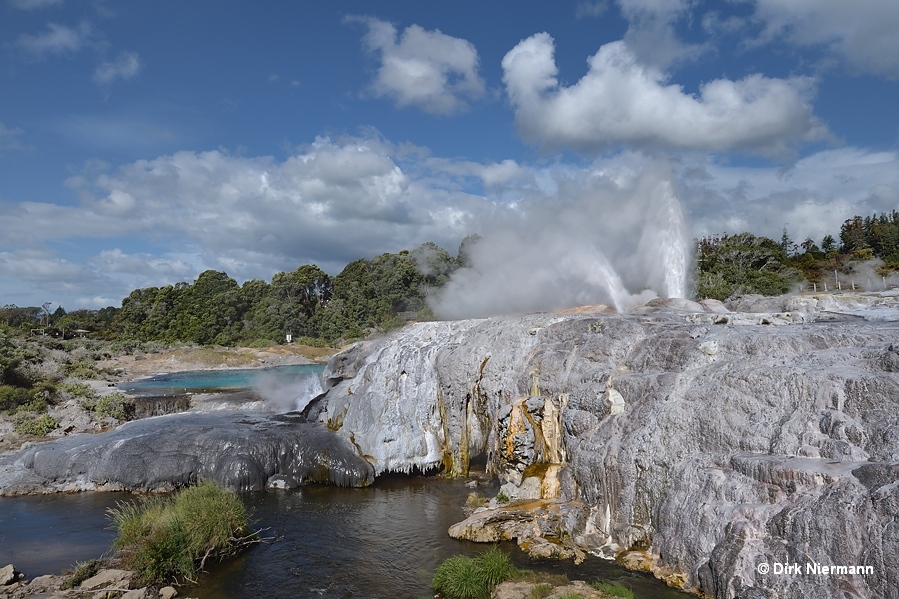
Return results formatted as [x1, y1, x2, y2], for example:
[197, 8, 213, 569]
[754, 0, 899, 78]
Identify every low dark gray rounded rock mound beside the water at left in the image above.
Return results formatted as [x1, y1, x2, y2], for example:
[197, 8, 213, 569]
[0, 412, 374, 495]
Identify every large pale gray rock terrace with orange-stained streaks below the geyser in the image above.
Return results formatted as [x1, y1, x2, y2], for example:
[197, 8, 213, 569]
[307, 300, 899, 599]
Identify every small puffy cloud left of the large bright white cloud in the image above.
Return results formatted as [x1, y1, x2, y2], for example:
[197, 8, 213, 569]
[354, 18, 484, 115]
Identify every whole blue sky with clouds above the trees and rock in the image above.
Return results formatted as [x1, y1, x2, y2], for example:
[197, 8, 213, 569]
[0, 0, 899, 312]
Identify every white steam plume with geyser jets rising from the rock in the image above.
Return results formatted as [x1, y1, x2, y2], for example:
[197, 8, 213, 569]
[431, 163, 689, 318]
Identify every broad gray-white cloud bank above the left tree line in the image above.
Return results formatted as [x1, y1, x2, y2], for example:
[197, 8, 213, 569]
[51, 138, 478, 277]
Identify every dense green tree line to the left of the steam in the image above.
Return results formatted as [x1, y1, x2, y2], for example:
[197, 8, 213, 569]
[0, 243, 464, 345]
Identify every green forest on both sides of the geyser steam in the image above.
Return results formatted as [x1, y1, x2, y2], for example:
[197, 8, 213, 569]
[0, 210, 899, 346]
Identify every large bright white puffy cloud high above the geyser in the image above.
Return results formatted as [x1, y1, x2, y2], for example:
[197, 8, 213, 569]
[502, 33, 828, 156]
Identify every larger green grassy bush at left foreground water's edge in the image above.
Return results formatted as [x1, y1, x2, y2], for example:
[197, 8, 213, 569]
[109, 481, 256, 584]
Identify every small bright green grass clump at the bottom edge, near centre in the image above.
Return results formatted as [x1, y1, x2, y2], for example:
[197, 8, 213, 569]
[431, 547, 515, 599]
